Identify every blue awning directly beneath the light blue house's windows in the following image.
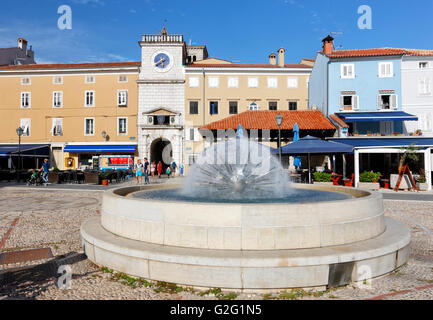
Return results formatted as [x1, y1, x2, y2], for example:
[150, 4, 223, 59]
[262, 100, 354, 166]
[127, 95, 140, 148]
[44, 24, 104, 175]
[337, 111, 418, 122]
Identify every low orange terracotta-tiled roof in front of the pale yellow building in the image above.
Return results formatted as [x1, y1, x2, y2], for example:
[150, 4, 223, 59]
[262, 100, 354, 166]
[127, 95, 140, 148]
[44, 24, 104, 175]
[201, 110, 336, 130]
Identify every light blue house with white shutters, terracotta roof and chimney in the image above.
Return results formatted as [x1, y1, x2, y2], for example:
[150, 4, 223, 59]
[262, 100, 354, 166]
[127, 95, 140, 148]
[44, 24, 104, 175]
[309, 36, 418, 136]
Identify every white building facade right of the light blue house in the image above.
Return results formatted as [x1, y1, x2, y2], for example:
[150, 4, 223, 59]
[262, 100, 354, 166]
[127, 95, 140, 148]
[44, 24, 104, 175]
[401, 49, 433, 137]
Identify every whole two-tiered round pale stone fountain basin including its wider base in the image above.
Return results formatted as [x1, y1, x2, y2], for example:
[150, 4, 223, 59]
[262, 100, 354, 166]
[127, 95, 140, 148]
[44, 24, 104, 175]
[81, 185, 410, 291]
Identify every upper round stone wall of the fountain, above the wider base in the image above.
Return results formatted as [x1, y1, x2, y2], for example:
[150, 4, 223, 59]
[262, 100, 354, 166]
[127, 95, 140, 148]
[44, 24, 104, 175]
[101, 185, 385, 250]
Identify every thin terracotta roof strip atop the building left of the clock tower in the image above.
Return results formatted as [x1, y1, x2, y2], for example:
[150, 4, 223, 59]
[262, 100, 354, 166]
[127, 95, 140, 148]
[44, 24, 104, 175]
[0, 62, 141, 70]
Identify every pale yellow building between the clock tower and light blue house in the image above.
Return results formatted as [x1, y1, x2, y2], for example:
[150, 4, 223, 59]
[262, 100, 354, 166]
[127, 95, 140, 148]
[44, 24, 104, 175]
[185, 53, 314, 165]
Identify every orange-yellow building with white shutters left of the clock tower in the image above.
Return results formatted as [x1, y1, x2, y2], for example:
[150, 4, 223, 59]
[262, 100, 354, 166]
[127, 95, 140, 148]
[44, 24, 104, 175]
[0, 62, 140, 169]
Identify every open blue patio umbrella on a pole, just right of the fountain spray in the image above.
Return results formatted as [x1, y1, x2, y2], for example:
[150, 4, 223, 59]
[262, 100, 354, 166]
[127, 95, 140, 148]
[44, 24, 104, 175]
[272, 136, 353, 183]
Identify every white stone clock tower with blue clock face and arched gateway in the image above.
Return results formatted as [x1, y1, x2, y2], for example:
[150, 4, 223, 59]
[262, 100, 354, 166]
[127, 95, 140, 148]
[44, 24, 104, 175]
[137, 26, 186, 172]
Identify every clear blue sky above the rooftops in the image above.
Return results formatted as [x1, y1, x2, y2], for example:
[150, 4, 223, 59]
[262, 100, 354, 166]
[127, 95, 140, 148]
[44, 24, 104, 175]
[0, 0, 433, 63]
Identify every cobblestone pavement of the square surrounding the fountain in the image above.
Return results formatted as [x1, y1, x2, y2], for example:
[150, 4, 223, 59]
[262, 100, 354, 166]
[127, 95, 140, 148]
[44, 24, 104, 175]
[0, 184, 433, 300]
